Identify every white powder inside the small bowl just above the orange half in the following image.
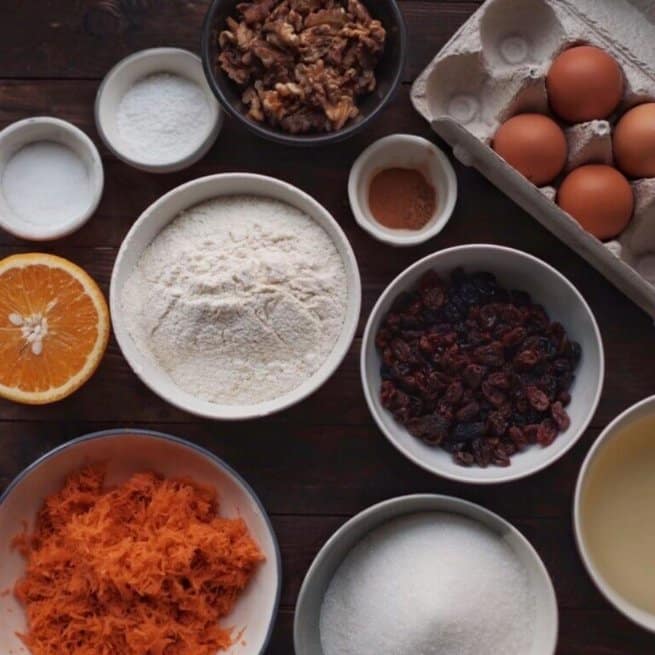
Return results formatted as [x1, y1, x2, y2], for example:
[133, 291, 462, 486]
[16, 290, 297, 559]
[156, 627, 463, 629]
[1, 141, 93, 225]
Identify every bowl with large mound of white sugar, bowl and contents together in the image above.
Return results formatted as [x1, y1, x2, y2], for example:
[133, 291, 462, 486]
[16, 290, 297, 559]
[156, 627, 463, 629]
[294, 494, 558, 655]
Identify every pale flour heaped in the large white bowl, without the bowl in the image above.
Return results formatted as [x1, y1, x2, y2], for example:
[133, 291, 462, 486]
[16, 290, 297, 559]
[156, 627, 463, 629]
[122, 196, 347, 404]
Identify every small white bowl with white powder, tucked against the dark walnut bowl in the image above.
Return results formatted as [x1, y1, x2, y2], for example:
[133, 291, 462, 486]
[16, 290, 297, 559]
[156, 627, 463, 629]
[95, 48, 223, 173]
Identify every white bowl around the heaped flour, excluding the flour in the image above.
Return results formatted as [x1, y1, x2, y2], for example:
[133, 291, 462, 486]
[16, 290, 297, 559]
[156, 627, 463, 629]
[109, 173, 361, 420]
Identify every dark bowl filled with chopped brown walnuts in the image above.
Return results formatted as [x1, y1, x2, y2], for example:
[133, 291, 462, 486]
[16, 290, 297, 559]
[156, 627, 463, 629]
[206, 0, 398, 136]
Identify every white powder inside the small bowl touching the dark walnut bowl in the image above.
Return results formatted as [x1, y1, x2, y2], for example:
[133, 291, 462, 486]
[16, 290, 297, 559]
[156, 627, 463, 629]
[116, 73, 211, 163]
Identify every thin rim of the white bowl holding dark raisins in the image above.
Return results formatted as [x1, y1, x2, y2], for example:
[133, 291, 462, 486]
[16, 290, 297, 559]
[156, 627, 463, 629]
[360, 243, 605, 485]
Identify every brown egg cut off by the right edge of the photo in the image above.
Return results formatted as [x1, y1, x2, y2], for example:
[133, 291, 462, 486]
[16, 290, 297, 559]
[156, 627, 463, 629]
[613, 102, 655, 177]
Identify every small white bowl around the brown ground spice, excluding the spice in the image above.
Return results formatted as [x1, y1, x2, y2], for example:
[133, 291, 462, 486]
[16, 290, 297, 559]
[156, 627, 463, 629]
[348, 134, 457, 246]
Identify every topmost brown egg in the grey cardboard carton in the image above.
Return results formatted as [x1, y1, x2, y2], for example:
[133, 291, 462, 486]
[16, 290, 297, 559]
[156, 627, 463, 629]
[546, 45, 623, 123]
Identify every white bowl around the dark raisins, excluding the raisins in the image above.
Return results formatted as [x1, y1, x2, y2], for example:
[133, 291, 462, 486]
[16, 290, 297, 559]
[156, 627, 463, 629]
[360, 244, 605, 484]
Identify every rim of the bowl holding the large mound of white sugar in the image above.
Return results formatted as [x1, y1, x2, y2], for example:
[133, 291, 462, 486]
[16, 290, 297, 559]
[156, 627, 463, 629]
[293, 494, 559, 655]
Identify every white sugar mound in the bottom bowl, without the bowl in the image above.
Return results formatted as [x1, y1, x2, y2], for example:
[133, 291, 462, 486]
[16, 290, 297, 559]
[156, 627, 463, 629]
[320, 512, 536, 655]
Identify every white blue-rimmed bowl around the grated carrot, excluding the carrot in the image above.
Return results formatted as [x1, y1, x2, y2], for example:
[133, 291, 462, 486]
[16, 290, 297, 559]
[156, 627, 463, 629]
[0, 430, 282, 655]
